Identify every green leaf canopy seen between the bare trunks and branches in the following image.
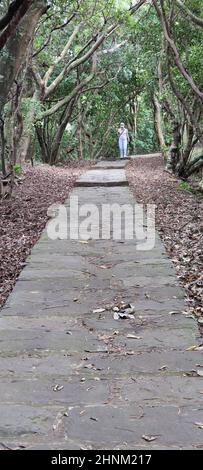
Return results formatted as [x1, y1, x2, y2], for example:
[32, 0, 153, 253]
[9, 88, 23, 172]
[3, 0, 203, 169]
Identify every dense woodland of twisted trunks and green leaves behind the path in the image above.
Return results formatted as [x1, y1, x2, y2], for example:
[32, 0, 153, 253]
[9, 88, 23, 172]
[0, 0, 203, 186]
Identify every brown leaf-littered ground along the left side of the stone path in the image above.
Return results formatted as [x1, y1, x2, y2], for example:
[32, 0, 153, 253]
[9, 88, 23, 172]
[0, 162, 90, 307]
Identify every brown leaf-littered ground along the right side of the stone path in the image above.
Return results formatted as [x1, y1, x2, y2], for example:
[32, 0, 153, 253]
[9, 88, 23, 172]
[128, 156, 203, 322]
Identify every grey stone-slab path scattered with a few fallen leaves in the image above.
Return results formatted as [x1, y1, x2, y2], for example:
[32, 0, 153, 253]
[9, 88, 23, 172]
[0, 162, 203, 450]
